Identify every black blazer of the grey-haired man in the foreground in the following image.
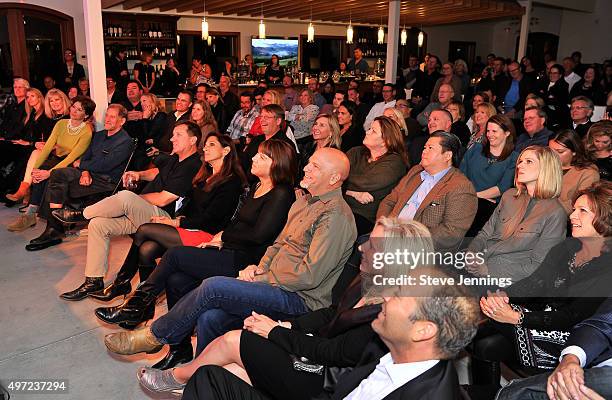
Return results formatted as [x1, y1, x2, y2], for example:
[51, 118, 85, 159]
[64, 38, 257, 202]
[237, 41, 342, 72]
[317, 339, 461, 400]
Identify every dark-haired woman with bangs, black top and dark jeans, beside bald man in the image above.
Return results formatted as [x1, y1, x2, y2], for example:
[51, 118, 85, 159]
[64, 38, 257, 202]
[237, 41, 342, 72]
[96, 138, 297, 369]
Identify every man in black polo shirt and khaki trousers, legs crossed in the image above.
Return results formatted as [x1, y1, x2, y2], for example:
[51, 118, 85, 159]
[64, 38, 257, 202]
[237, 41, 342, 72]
[60, 122, 202, 301]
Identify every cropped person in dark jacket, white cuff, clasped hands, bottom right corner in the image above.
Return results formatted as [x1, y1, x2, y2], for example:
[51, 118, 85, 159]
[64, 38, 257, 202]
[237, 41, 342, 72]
[496, 299, 612, 400]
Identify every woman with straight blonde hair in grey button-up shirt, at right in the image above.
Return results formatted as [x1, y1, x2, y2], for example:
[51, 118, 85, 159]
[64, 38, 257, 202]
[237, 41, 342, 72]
[467, 146, 567, 283]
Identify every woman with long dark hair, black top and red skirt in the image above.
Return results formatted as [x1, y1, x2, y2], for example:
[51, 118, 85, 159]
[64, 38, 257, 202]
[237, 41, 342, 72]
[90, 133, 246, 301]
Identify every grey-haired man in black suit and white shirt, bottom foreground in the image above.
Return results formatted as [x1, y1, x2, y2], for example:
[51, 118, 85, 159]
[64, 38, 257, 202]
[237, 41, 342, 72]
[183, 269, 480, 400]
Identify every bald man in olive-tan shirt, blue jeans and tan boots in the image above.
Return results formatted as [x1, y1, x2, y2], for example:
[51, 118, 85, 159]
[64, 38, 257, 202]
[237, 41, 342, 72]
[104, 148, 357, 360]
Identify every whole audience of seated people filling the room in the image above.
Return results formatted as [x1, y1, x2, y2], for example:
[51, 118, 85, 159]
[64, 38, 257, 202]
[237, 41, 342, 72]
[0, 44, 612, 399]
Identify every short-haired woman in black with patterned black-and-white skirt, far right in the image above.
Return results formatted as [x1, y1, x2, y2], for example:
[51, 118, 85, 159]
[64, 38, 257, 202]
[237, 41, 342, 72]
[472, 181, 612, 393]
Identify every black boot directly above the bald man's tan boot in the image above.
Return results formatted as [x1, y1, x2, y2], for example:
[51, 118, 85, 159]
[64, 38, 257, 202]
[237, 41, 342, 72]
[95, 290, 157, 329]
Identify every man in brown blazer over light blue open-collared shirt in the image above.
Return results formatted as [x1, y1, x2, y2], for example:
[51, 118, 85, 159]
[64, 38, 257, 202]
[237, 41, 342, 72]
[376, 131, 478, 250]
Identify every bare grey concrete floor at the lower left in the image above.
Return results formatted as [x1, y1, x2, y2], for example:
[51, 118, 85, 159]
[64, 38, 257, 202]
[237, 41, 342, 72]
[0, 205, 172, 400]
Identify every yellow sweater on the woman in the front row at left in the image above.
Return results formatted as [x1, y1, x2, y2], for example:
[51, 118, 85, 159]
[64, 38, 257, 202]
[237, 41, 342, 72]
[34, 119, 91, 169]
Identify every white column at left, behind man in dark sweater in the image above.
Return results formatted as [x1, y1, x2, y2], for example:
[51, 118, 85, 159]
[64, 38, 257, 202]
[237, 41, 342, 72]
[83, 0, 108, 130]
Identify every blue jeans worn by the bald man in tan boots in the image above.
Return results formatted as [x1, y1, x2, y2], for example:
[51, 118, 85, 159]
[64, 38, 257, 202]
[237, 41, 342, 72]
[151, 276, 309, 354]
